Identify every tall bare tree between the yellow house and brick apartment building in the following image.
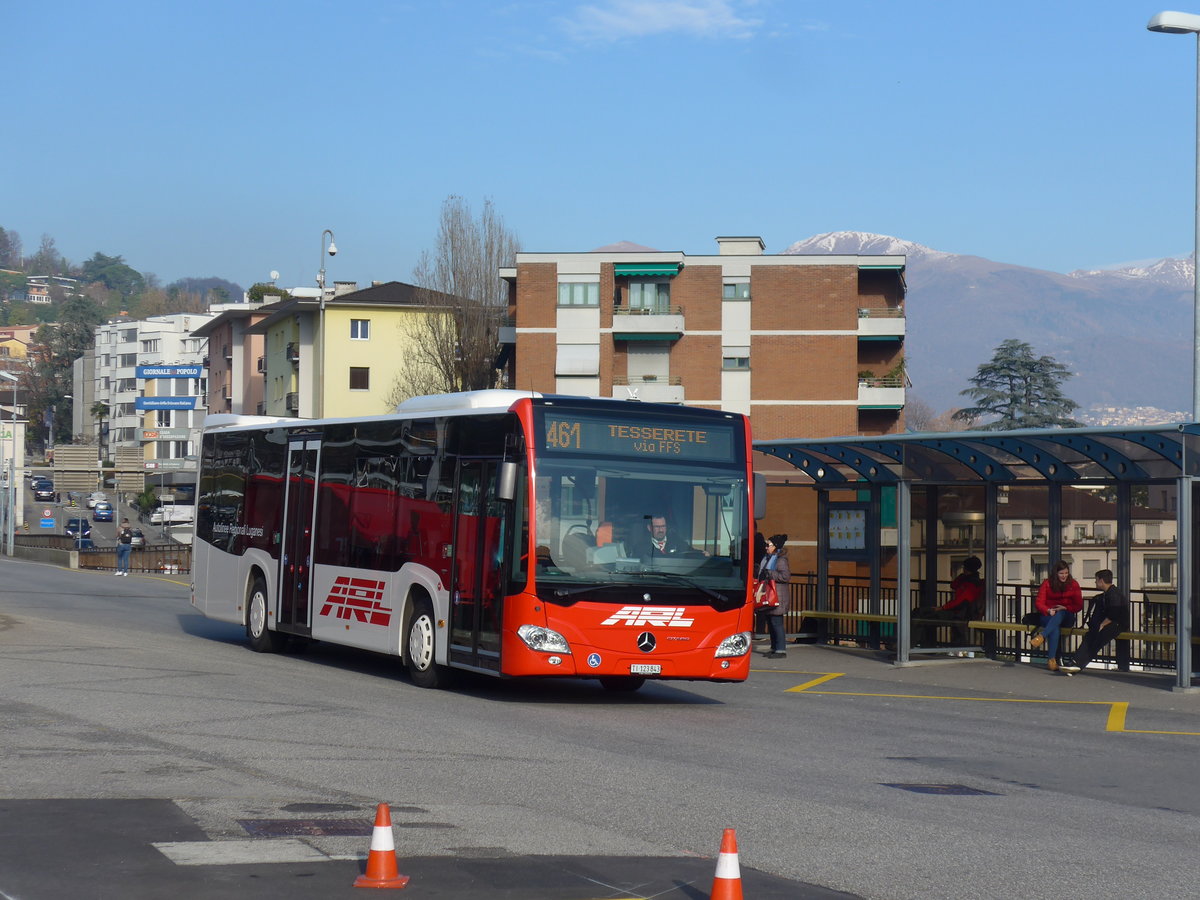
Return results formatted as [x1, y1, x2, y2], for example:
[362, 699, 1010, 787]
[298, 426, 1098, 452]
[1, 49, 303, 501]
[388, 196, 520, 404]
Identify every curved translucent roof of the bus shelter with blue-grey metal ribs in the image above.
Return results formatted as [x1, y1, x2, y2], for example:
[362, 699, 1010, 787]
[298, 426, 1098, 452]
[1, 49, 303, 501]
[754, 424, 1200, 486]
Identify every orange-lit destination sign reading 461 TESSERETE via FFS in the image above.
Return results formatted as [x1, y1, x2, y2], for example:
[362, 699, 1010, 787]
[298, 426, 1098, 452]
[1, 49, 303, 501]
[541, 410, 736, 462]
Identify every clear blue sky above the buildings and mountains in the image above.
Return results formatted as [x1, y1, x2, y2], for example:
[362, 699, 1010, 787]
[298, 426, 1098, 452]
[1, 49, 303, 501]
[9, 0, 1200, 287]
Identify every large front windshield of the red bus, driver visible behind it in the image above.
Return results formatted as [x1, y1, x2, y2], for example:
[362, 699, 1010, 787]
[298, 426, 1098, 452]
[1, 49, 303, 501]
[533, 455, 750, 606]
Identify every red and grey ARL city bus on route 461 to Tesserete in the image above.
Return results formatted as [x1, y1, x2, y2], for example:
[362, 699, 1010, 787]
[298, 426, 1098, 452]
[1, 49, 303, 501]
[192, 390, 754, 690]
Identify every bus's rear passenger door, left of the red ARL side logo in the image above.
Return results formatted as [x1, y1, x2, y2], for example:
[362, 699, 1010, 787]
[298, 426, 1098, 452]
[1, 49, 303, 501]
[276, 440, 320, 635]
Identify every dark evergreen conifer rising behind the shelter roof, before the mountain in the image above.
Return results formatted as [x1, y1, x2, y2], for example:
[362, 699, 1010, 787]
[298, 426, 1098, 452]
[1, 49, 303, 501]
[954, 338, 1079, 431]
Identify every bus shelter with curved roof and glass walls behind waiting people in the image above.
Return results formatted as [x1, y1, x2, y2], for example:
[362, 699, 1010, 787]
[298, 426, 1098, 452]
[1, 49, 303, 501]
[754, 424, 1200, 690]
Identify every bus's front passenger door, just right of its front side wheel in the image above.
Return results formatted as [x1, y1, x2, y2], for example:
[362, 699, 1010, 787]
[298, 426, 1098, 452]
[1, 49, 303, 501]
[450, 460, 508, 672]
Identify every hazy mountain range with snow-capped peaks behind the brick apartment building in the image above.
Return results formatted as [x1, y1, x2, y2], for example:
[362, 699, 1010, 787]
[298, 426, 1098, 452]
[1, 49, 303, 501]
[784, 232, 1194, 412]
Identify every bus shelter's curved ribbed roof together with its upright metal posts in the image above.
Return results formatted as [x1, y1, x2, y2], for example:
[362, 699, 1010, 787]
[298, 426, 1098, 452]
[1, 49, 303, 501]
[754, 422, 1200, 690]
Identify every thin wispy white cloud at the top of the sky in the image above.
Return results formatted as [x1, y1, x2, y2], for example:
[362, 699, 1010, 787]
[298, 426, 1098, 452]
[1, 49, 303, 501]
[563, 0, 762, 41]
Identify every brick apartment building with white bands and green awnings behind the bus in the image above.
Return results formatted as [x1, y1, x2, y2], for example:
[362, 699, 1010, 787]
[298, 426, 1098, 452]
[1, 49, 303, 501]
[500, 236, 906, 556]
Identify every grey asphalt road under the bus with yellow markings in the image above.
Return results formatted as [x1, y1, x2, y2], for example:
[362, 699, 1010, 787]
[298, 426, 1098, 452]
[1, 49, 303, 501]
[0, 559, 1200, 900]
